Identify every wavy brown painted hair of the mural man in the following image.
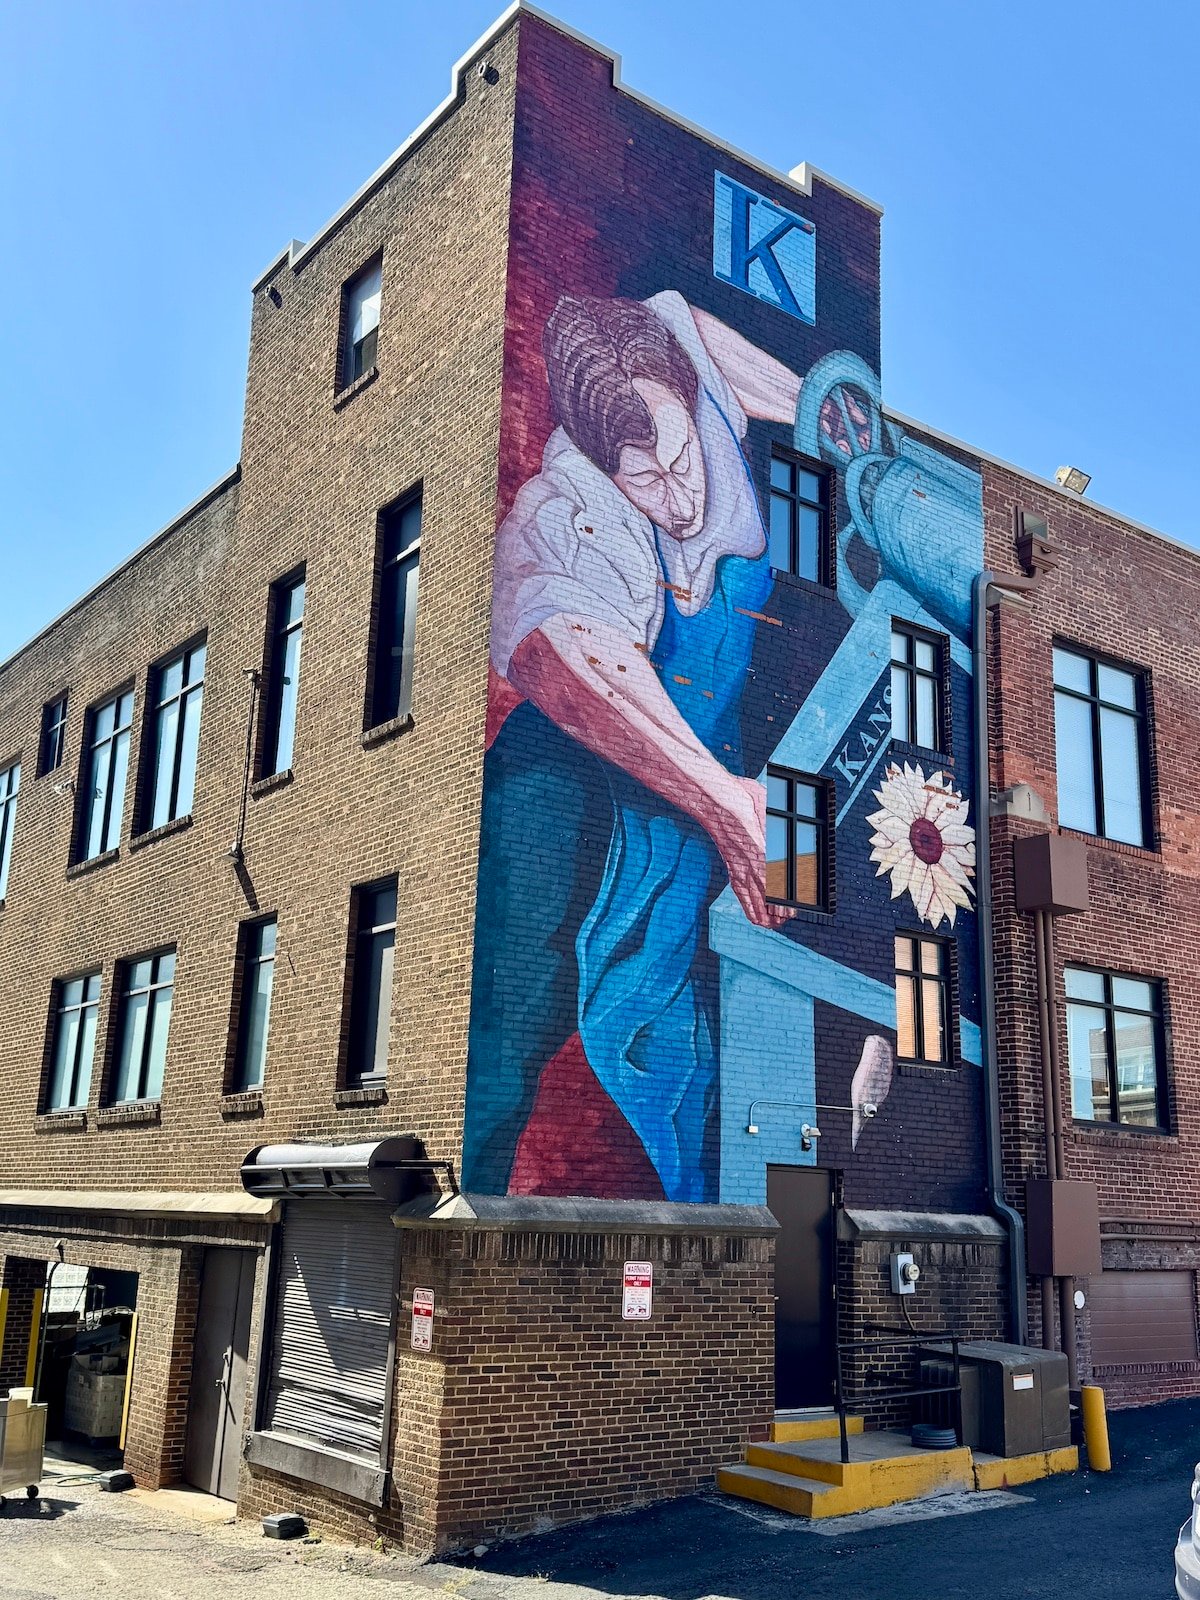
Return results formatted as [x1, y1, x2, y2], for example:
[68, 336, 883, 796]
[542, 294, 699, 477]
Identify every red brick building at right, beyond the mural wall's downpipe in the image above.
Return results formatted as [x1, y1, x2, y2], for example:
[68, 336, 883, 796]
[984, 462, 1200, 1405]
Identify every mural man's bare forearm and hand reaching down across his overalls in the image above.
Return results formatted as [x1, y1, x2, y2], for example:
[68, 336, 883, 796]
[509, 616, 782, 928]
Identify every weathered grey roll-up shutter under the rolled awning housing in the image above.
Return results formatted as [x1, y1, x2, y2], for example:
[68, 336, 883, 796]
[266, 1198, 397, 1461]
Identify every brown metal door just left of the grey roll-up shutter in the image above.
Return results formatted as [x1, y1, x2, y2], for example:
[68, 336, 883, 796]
[184, 1248, 256, 1499]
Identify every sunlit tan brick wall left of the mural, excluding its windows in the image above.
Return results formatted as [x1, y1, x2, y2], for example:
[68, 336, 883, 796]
[0, 18, 515, 1189]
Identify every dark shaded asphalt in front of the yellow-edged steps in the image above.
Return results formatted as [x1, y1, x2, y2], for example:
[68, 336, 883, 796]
[464, 1400, 1200, 1600]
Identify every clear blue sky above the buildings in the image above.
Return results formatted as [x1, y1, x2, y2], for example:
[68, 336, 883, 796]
[0, 0, 1200, 659]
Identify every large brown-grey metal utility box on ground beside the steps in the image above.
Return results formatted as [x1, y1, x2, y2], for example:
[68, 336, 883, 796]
[922, 1339, 1070, 1456]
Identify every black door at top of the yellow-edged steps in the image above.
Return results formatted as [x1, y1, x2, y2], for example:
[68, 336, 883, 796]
[766, 1166, 837, 1411]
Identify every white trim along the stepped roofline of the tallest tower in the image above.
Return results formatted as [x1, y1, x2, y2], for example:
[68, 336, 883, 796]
[250, 0, 883, 294]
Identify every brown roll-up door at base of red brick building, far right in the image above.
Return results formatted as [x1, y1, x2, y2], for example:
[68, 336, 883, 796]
[1088, 1270, 1197, 1366]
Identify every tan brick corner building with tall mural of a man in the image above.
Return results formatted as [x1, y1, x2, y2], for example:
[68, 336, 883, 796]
[0, 6, 1186, 1550]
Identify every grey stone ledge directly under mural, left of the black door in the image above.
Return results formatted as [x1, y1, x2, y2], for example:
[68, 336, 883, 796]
[392, 1194, 779, 1235]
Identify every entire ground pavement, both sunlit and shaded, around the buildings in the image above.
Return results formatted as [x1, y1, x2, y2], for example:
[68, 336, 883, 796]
[0, 1402, 1200, 1600]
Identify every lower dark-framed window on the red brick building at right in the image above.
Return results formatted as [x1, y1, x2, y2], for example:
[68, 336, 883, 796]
[1062, 966, 1166, 1128]
